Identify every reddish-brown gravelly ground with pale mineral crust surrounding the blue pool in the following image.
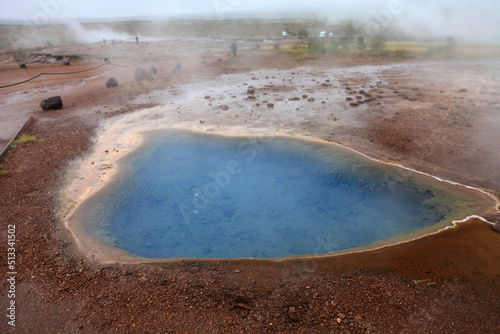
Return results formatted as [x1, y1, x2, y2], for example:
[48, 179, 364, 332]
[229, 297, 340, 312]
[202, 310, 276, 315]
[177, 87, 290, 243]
[0, 36, 500, 333]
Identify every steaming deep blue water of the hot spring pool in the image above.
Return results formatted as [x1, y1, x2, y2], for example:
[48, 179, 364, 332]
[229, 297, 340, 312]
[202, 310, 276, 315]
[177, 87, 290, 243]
[86, 130, 458, 258]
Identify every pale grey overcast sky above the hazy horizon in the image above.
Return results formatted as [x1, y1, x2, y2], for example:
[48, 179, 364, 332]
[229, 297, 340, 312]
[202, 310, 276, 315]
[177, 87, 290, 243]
[0, 0, 500, 44]
